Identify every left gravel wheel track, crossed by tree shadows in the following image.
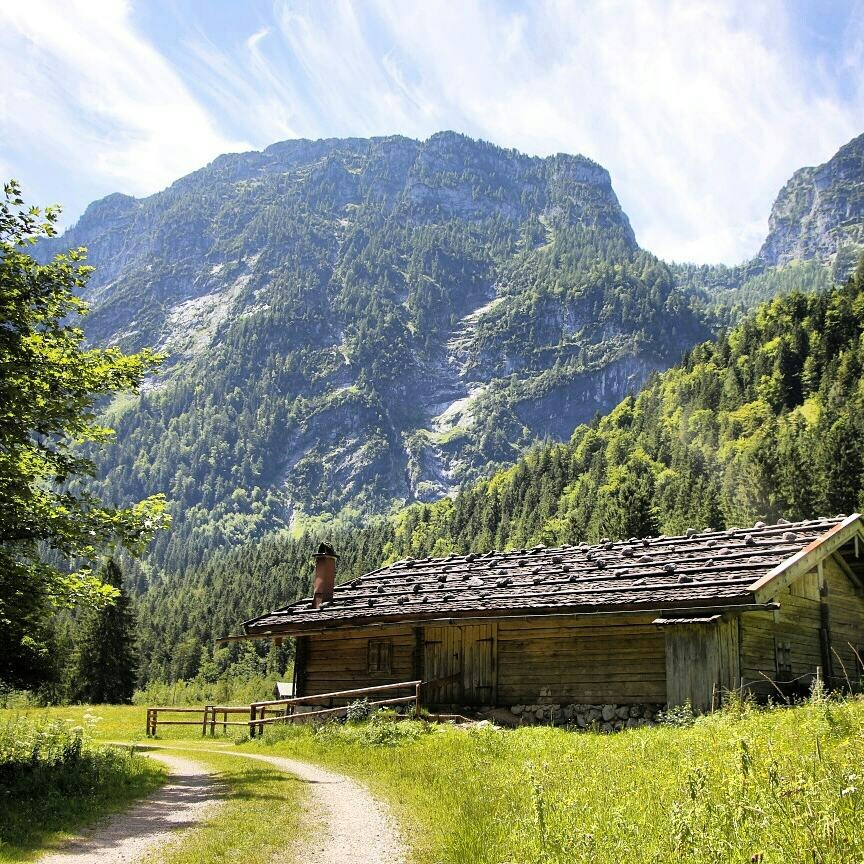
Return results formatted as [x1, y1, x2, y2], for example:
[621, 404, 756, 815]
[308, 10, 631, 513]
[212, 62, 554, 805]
[38, 751, 221, 864]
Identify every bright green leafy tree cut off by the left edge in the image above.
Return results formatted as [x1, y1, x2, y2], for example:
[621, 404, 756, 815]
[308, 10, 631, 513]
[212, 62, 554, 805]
[0, 181, 165, 687]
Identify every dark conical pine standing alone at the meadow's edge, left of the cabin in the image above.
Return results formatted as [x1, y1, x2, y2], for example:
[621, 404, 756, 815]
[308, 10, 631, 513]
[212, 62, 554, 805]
[71, 558, 137, 704]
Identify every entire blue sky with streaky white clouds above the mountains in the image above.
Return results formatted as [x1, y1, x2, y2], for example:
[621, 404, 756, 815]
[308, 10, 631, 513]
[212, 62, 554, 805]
[0, 0, 864, 263]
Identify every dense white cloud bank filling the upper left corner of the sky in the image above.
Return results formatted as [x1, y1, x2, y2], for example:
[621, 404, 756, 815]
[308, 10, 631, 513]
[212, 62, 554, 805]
[0, 0, 249, 206]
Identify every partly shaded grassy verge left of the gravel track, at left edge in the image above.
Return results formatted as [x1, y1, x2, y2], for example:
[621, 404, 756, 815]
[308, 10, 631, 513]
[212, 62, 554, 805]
[0, 715, 165, 862]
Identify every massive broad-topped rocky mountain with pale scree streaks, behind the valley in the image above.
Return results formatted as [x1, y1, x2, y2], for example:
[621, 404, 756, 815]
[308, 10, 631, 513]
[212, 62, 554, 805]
[38, 132, 864, 568]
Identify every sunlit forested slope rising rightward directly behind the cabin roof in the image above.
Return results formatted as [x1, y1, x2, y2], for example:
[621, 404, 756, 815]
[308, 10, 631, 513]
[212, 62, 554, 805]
[132, 264, 864, 678]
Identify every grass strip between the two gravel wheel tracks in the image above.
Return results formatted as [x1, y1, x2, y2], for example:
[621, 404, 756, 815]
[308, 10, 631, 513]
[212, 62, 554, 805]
[140, 745, 305, 864]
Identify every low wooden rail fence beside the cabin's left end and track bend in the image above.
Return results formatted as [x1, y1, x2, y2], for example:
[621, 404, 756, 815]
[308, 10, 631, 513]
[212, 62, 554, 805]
[147, 681, 421, 738]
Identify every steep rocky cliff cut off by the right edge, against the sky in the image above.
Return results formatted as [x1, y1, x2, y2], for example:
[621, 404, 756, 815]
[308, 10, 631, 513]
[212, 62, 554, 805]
[759, 135, 864, 273]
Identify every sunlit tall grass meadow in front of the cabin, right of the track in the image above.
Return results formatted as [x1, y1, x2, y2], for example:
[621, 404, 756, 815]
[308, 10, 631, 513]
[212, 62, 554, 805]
[244, 698, 864, 864]
